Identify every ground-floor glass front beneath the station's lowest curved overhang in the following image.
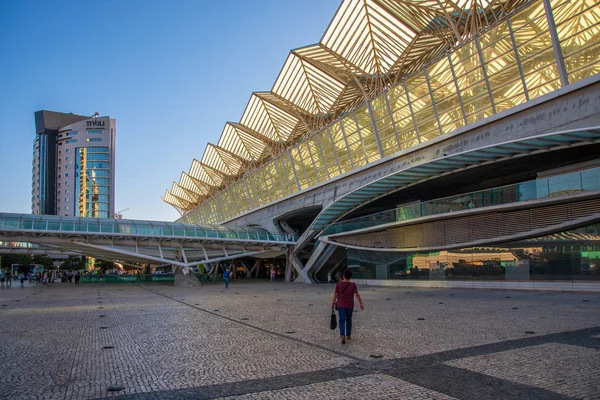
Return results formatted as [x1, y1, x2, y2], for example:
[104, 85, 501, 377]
[347, 224, 600, 281]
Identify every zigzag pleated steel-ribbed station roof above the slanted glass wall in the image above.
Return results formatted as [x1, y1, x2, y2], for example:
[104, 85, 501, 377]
[163, 0, 528, 215]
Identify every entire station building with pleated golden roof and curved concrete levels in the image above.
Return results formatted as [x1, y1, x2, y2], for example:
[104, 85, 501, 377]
[163, 0, 600, 283]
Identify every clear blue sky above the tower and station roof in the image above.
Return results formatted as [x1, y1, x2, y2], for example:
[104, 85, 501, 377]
[0, 0, 339, 221]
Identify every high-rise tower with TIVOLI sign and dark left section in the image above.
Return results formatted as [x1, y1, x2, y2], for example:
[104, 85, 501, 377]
[31, 110, 116, 218]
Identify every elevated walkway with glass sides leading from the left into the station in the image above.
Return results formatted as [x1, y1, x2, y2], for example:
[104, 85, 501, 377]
[0, 213, 296, 267]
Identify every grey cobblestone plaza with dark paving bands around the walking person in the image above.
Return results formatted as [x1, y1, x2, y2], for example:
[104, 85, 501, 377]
[0, 281, 600, 400]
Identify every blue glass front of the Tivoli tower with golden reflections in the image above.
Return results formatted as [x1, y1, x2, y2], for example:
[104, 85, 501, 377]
[75, 147, 112, 218]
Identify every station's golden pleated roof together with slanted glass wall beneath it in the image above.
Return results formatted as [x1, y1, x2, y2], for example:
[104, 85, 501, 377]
[163, 0, 600, 227]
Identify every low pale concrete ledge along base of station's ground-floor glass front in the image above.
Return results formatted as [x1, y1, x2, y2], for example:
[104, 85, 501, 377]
[354, 279, 600, 293]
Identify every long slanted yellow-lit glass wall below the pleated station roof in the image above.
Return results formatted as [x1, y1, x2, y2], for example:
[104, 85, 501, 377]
[180, 0, 600, 223]
